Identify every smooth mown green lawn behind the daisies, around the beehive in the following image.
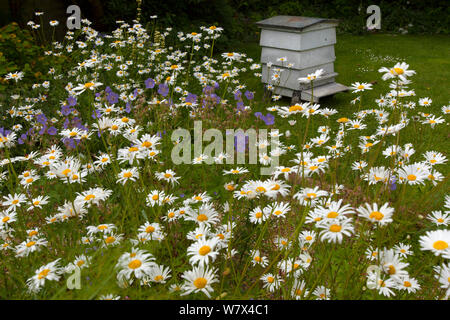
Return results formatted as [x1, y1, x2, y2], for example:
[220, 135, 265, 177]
[233, 34, 450, 176]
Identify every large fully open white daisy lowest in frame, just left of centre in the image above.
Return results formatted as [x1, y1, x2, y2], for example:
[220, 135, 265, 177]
[181, 266, 218, 298]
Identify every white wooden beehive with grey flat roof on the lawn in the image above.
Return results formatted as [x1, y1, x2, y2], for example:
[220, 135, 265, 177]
[256, 16, 348, 102]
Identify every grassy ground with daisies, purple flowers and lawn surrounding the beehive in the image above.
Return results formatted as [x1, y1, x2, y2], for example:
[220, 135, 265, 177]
[0, 17, 450, 299]
